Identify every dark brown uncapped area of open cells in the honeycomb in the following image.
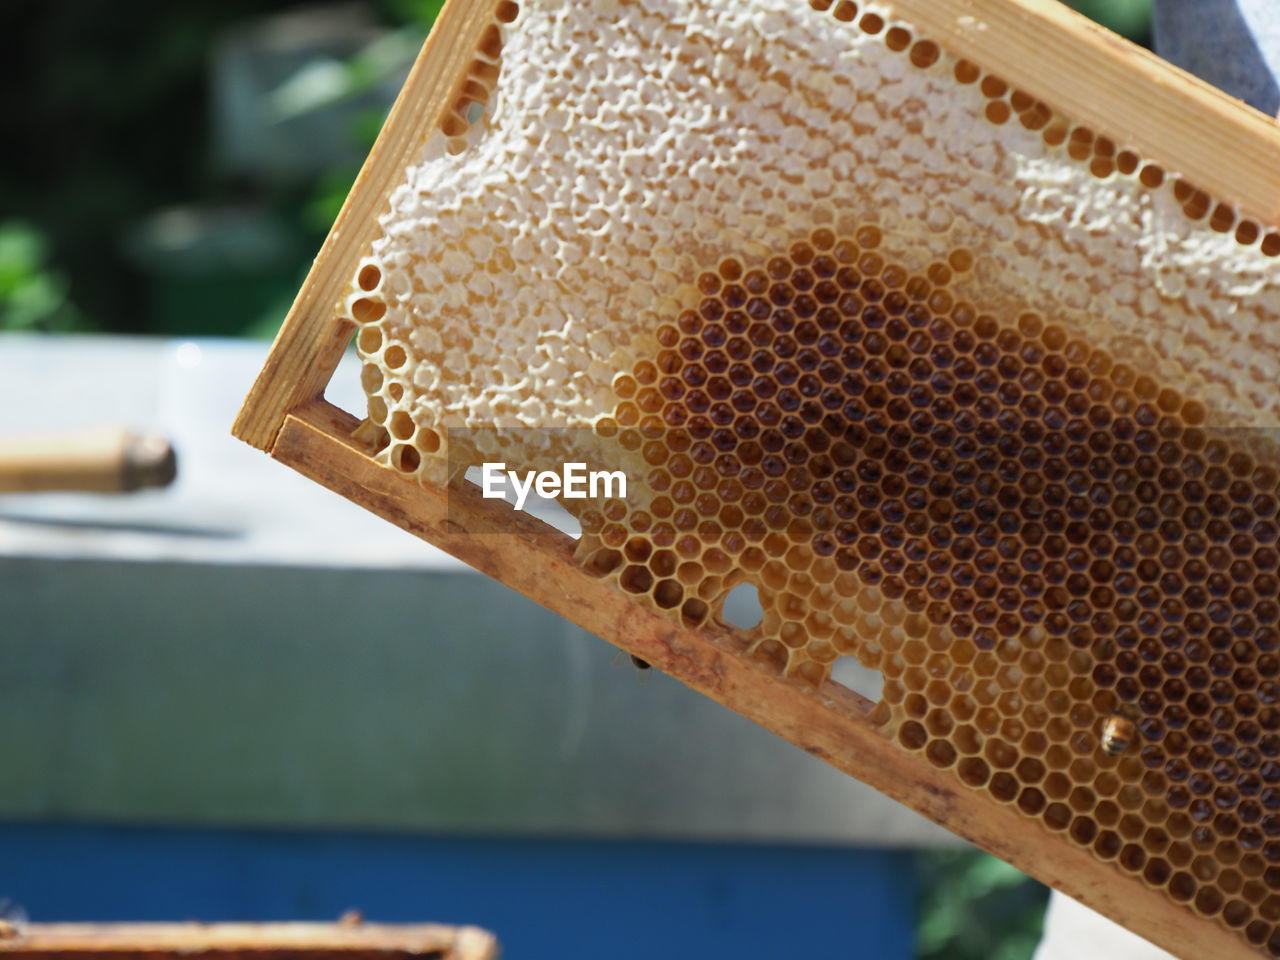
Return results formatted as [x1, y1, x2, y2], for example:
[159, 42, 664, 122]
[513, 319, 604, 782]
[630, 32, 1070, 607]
[581, 227, 1280, 951]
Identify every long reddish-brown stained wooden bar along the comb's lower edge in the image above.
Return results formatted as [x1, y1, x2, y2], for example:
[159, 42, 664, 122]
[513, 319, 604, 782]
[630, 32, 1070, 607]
[271, 401, 1258, 960]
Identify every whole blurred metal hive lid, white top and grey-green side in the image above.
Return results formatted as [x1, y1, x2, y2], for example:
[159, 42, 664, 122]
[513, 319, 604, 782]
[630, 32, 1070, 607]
[0, 335, 957, 846]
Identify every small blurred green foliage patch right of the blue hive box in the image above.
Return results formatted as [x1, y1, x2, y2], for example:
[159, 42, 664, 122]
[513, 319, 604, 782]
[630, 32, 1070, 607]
[916, 850, 1048, 960]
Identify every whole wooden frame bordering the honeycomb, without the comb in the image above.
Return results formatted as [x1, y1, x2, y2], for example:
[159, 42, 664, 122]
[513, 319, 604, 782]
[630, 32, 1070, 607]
[233, 0, 1280, 957]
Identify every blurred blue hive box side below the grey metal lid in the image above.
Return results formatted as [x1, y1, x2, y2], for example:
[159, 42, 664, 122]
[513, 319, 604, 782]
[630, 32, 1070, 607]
[0, 824, 915, 960]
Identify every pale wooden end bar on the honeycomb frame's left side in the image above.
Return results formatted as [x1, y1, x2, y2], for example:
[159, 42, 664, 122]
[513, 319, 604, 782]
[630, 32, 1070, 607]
[232, 0, 494, 451]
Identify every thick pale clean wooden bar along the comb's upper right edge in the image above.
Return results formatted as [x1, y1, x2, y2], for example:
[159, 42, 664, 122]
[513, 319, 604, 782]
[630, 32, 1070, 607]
[888, 0, 1280, 228]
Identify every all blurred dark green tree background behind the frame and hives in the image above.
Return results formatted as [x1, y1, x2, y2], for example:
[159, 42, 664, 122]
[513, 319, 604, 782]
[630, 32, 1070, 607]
[0, 0, 1151, 960]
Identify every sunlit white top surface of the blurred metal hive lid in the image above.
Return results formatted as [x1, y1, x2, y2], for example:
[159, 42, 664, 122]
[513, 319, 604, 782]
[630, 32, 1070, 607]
[0, 335, 462, 570]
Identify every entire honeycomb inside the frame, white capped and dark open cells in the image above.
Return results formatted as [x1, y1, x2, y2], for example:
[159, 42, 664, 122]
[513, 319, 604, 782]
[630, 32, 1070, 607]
[338, 0, 1280, 956]
